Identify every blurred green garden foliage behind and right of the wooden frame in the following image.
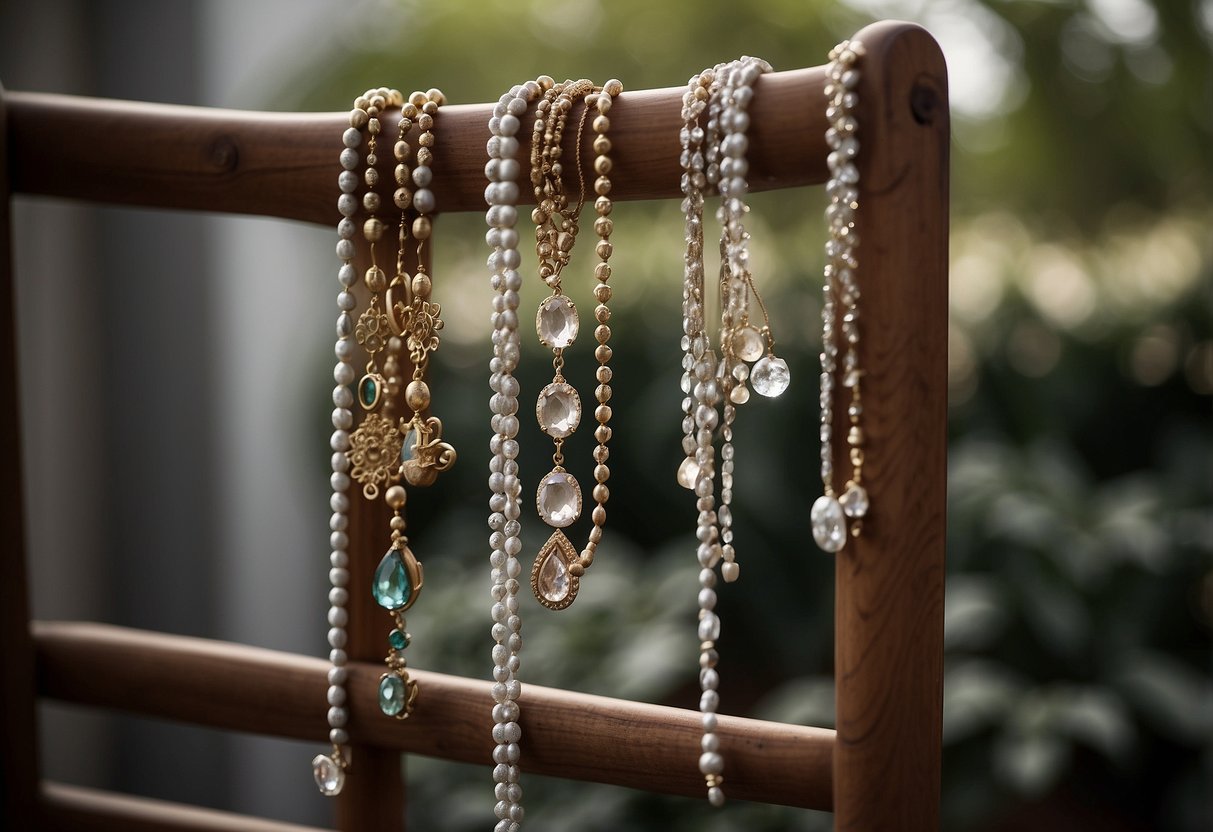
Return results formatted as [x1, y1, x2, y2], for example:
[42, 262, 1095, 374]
[288, 0, 1213, 832]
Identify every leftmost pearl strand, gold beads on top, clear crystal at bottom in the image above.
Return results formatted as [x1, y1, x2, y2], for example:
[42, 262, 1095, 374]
[312, 83, 400, 797]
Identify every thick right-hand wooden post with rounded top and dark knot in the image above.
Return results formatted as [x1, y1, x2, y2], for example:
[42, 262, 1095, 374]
[835, 23, 949, 832]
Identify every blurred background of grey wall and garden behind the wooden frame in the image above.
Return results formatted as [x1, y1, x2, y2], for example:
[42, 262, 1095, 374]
[0, 0, 1213, 832]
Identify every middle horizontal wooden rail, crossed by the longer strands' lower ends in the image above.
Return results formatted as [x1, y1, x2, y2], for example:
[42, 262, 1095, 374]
[34, 621, 833, 809]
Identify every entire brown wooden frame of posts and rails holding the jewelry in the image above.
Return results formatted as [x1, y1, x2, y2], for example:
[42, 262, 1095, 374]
[0, 17, 949, 830]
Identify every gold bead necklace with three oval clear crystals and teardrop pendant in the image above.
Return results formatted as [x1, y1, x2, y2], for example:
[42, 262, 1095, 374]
[531, 79, 623, 610]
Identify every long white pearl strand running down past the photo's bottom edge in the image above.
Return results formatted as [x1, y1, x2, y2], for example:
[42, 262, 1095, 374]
[484, 81, 542, 832]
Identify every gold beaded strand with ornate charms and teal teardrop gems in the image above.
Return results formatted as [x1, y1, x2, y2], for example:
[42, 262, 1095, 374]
[372, 90, 456, 719]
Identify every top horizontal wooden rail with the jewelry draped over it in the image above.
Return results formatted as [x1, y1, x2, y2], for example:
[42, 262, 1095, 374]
[7, 68, 826, 226]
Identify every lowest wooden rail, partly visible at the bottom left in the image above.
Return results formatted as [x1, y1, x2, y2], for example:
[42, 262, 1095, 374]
[41, 782, 332, 832]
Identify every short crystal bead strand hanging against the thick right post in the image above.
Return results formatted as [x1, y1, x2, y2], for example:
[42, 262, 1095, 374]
[809, 40, 869, 552]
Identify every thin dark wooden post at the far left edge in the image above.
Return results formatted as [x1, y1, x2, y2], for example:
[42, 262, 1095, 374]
[0, 81, 40, 830]
